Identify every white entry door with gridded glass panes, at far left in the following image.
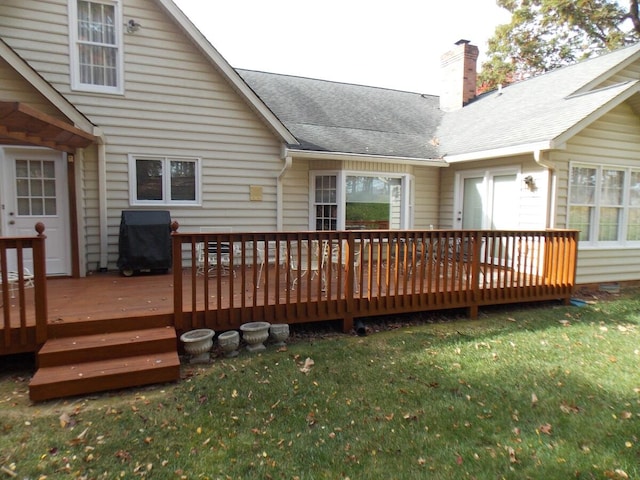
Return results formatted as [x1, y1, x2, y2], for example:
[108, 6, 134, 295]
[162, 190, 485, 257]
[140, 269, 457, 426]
[0, 148, 71, 275]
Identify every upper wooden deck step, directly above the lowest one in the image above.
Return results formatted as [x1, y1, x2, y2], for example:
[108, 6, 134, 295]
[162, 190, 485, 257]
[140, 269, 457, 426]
[37, 327, 177, 368]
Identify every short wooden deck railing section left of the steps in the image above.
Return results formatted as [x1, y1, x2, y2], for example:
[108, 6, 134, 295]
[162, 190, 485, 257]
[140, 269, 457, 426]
[0, 223, 47, 353]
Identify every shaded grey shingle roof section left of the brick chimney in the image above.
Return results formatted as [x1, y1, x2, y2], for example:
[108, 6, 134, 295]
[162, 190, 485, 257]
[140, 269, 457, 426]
[238, 70, 442, 159]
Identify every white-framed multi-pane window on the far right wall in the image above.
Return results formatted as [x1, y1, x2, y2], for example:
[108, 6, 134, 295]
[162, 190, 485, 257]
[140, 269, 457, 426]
[568, 164, 640, 245]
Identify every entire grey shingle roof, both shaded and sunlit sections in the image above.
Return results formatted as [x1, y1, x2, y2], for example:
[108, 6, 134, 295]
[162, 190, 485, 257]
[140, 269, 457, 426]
[238, 43, 640, 159]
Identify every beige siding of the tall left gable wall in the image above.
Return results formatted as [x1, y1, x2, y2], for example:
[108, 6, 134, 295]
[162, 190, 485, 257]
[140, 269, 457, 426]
[0, 0, 283, 270]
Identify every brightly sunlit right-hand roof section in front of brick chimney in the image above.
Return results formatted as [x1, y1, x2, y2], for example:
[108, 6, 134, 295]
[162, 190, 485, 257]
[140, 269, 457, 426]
[438, 44, 640, 161]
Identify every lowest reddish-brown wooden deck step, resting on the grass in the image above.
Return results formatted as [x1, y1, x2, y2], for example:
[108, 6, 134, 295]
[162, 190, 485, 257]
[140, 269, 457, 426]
[29, 348, 180, 402]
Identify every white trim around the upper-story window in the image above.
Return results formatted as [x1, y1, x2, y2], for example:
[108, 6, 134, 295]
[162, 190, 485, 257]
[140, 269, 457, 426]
[68, 0, 124, 95]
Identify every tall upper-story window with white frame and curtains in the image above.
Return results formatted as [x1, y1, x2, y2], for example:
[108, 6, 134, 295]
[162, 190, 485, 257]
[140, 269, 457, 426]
[69, 0, 123, 93]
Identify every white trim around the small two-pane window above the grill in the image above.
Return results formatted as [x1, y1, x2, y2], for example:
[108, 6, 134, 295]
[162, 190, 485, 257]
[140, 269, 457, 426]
[128, 153, 202, 207]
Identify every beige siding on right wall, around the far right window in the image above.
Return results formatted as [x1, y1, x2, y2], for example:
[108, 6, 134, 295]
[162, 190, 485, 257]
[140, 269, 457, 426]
[552, 100, 640, 283]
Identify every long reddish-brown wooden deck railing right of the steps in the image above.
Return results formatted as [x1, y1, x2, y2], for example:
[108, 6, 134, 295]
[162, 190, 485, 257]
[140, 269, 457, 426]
[173, 229, 577, 331]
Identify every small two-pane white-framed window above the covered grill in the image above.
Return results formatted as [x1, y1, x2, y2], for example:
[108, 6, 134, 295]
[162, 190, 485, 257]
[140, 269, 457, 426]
[129, 155, 200, 205]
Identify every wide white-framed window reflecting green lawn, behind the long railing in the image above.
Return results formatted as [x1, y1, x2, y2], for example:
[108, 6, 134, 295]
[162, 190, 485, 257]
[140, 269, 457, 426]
[311, 172, 410, 230]
